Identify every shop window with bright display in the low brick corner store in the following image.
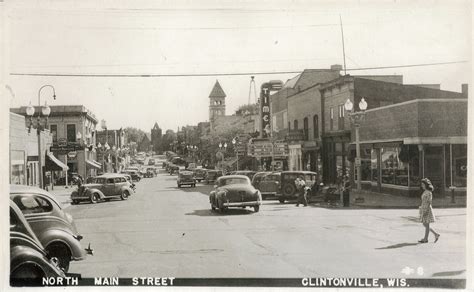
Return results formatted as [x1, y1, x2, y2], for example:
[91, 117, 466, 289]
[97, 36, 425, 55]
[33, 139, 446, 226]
[381, 147, 408, 186]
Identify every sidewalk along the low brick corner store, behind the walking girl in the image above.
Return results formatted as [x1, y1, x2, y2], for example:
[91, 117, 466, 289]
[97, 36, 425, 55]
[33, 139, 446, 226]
[350, 190, 467, 209]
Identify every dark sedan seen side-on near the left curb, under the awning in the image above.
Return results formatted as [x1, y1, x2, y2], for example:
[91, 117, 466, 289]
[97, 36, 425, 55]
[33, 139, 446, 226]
[71, 173, 133, 204]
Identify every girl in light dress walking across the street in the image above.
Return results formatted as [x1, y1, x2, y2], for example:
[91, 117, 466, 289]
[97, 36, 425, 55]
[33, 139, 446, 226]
[418, 178, 440, 243]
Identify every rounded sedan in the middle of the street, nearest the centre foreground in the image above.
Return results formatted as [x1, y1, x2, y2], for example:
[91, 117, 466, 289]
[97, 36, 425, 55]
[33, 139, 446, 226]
[209, 175, 262, 212]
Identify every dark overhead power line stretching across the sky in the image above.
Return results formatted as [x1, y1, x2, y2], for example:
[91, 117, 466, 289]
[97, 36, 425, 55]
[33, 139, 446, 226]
[10, 61, 468, 78]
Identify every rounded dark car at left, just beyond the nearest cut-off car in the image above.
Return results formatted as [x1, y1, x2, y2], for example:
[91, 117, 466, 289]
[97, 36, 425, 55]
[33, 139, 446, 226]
[10, 185, 91, 271]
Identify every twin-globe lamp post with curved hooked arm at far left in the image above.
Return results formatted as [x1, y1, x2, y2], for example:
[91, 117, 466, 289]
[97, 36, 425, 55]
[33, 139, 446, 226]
[26, 85, 56, 188]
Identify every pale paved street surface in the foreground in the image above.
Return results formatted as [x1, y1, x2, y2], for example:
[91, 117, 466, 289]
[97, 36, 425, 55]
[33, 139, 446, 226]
[67, 169, 466, 278]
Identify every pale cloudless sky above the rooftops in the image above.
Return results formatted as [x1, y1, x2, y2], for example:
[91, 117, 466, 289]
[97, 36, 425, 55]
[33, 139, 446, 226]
[4, 0, 472, 131]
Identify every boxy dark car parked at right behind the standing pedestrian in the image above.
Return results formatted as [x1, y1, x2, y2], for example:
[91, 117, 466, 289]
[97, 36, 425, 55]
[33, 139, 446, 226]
[276, 171, 319, 203]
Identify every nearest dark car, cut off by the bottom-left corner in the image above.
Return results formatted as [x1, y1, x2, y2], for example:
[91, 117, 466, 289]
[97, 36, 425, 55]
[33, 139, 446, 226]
[10, 200, 66, 287]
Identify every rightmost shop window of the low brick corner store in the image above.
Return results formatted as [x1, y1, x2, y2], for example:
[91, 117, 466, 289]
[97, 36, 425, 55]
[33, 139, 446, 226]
[445, 144, 467, 187]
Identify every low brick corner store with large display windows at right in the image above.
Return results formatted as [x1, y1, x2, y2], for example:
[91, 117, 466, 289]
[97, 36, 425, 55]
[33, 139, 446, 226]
[354, 99, 467, 196]
